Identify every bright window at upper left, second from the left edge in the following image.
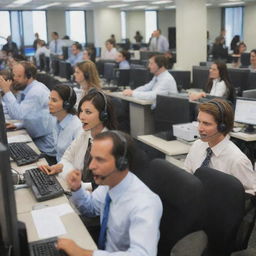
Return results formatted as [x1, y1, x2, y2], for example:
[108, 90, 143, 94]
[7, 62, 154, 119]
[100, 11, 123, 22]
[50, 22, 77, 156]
[22, 11, 47, 45]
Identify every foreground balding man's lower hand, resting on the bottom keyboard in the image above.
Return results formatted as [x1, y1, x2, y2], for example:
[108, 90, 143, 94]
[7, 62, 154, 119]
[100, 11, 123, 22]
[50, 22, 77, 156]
[56, 238, 93, 256]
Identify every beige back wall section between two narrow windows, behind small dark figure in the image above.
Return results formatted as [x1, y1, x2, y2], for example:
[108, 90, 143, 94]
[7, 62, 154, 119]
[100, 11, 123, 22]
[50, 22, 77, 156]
[126, 11, 145, 43]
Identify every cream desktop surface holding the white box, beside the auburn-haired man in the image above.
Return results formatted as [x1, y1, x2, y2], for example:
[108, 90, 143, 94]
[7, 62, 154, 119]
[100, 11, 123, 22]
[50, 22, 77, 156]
[137, 135, 191, 156]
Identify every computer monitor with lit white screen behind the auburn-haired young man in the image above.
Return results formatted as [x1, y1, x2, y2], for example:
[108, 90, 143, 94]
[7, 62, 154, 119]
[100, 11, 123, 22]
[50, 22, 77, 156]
[235, 98, 256, 133]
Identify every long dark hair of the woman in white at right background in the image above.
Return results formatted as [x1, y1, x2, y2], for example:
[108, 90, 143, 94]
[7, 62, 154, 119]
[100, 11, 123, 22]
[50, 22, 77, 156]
[206, 60, 235, 103]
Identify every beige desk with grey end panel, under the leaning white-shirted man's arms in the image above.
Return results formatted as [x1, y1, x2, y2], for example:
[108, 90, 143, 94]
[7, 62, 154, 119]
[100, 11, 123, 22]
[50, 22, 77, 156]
[106, 92, 154, 138]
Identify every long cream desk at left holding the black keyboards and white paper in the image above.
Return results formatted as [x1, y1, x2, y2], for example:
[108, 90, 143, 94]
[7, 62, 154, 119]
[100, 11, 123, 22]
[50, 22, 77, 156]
[8, 130, 97, 250]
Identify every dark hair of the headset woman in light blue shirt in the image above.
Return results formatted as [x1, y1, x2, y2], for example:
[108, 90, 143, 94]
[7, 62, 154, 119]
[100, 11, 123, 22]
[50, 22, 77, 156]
[52, 84, 76, 115]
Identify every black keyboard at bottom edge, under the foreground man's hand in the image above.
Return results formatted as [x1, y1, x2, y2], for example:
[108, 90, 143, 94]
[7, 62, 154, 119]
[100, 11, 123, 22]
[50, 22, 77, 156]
[29, 237, 67, 256]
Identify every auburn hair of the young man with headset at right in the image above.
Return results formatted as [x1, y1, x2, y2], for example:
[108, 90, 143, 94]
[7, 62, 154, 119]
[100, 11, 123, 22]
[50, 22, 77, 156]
[199, 98, 234, 135]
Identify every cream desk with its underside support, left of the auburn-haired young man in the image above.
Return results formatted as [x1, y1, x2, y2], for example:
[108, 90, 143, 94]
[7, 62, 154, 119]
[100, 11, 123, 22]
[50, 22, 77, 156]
[137, 135, 191, 168]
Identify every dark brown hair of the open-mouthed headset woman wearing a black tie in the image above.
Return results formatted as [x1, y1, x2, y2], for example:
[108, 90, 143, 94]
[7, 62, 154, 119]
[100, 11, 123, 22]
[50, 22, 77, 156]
[77, 90, 117, 130]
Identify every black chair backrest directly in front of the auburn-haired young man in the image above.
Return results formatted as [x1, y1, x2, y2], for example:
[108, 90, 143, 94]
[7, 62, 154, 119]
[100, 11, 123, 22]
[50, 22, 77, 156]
[195, 167, 245, 256]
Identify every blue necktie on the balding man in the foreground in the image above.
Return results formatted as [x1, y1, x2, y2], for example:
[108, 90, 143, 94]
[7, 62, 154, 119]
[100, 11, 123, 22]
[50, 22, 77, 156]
[98, 193, 111, 250]
